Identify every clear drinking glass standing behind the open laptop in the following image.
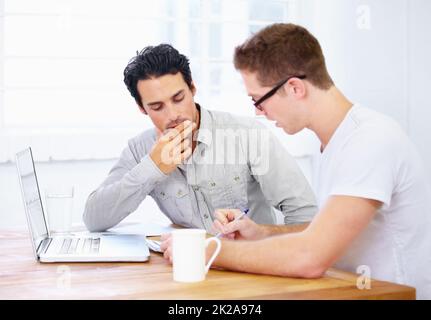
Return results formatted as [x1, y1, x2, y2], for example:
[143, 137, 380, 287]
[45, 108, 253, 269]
[45, 186, 74, 234]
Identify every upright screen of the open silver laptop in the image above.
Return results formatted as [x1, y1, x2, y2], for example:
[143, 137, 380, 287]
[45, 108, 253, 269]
[16, 148, 48, 254]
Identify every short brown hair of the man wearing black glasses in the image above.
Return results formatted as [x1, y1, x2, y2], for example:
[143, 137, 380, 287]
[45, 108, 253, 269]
[234, 23, 334, 90]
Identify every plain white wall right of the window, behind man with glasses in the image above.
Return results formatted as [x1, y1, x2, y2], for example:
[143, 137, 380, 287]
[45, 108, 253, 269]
[299, 0, 431, 181]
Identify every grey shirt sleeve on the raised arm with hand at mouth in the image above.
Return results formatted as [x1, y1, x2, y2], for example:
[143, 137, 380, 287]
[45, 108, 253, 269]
[83, 141, 167, 232]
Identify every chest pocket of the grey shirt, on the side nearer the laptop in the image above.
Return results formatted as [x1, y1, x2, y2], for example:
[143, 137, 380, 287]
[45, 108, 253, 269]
[155, 184, 193, 227]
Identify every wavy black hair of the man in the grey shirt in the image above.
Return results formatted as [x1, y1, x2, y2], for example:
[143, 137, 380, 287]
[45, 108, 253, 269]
[124, 43, 192, 108]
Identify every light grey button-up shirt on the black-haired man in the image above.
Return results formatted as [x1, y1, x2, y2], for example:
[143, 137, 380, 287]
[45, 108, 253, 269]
[83, 106, 317, 231]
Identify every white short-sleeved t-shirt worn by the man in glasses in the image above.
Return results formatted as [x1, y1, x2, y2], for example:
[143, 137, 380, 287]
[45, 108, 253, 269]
[316, 105, 431, 299]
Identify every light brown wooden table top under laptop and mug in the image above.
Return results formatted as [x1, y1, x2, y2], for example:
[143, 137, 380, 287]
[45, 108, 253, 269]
[0, 231, 415, 300]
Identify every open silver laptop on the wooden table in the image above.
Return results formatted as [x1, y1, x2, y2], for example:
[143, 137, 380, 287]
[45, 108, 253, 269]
[16, 148, 150, 262]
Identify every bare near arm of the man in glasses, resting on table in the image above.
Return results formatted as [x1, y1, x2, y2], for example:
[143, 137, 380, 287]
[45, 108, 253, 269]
[209, 196, 382, 278]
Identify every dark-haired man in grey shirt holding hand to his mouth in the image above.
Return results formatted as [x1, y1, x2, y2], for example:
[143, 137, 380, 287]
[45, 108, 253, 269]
[83, 44, 317, 232]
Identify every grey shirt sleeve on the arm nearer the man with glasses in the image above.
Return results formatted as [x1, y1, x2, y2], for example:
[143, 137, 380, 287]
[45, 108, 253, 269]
[249, 124, 317, 224]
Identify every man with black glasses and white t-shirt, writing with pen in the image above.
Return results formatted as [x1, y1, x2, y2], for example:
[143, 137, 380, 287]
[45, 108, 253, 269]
[162, 24, 431, 298]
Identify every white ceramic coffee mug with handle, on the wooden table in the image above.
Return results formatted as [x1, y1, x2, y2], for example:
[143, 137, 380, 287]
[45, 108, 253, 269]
[172, 229, 221, 282]
